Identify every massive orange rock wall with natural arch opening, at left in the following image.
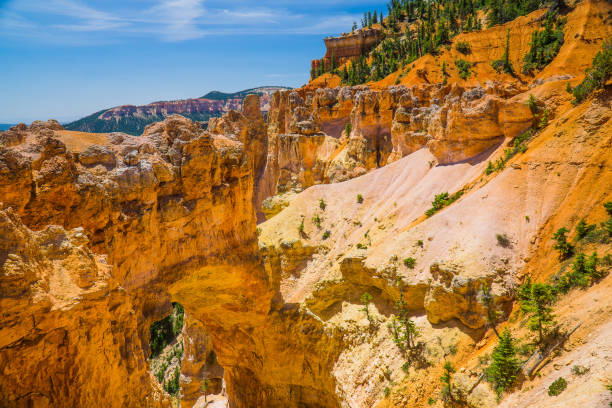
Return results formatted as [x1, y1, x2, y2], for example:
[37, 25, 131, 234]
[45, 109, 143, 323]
[0, 111, 350, 408]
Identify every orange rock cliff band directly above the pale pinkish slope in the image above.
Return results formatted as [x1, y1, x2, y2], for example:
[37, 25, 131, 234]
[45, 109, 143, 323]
[256, 83, 533, 215]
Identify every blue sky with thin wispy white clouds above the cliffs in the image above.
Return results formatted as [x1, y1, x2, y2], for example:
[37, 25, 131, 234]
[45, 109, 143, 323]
[0, 0, 387, 123]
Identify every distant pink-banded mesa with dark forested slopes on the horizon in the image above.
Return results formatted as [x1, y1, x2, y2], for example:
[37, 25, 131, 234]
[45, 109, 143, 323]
[64, 86, 291, 135]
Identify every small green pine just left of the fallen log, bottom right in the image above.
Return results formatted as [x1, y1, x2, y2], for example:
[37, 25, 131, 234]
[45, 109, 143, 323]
[487, 329, 520, 396]
